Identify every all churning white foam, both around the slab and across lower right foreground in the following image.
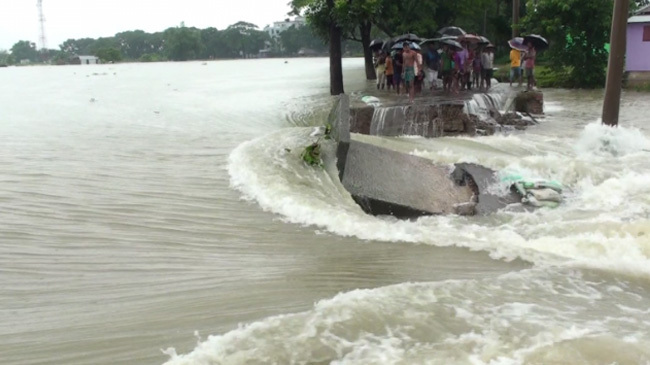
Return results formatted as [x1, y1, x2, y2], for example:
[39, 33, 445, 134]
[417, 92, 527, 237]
[165, 102, 650, 365]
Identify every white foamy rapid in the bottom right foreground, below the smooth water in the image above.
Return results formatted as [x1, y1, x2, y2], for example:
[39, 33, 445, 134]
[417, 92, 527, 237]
[166, 270, 650, 365]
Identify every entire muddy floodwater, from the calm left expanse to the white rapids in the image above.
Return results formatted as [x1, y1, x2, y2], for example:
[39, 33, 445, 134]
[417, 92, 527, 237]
[0, 59, 650, 364]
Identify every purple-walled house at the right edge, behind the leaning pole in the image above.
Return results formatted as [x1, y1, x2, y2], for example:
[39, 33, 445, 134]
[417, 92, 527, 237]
[625, 5, 650, 86]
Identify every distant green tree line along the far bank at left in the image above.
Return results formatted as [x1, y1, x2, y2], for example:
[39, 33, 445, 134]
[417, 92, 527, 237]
[0, 22, 362, 64]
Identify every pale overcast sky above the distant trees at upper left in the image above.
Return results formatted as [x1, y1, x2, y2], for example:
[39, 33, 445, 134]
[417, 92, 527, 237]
[0, 0, 290, 50]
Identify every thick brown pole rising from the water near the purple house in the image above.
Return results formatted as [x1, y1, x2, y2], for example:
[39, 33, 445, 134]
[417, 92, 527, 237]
[603, 0, 629, 126]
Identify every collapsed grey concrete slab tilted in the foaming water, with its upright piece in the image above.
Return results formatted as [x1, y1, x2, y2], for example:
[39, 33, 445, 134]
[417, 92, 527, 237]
[329, 95, 519, 218]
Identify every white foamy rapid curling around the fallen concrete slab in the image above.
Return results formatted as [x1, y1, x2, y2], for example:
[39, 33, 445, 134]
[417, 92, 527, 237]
[228, 124, 650, 275]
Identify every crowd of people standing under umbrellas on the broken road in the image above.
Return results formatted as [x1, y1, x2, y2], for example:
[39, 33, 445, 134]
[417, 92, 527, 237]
[375, 40, 537, 102]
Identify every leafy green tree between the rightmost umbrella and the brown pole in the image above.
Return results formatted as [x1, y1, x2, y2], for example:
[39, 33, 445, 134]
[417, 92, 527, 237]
[522, 0, 613, 88]
